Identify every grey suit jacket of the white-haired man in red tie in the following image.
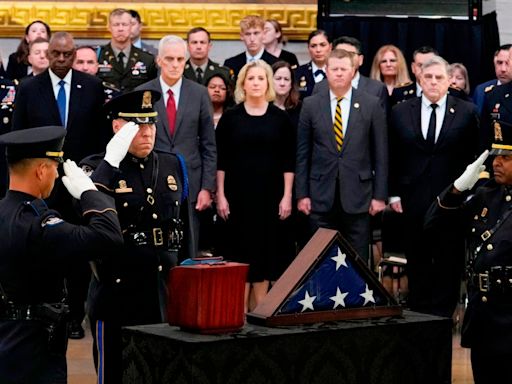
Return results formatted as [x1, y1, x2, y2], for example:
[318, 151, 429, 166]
[137, 78, 217, 206]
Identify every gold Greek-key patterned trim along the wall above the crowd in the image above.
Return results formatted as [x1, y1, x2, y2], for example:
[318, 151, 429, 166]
[0, 1, 317, 40]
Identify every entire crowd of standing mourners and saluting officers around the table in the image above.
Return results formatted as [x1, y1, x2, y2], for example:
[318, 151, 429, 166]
[0, 8, 512, 383]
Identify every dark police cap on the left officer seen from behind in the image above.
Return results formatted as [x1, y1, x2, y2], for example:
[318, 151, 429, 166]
[0, 126, 66, 163]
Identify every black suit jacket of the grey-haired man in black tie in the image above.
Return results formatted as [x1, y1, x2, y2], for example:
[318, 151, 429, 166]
[389, 95, 479, 215]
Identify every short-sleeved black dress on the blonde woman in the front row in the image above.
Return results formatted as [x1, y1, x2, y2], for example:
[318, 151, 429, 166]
[216, 103, 295, 282]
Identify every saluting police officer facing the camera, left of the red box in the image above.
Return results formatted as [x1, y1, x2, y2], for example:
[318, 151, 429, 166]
[81, 90, 187, 383]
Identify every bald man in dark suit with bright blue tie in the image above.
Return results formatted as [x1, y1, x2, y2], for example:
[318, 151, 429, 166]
[12, 32, 111, 338]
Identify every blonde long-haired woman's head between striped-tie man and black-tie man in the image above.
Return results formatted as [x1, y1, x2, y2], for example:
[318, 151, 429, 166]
[370, 44, 411, 96]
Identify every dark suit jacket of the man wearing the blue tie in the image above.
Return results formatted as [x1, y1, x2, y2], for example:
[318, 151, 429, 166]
[12, 69, 108, 163]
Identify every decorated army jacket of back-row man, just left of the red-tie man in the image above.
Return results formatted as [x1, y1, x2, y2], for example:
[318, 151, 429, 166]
[97, 43, 157, 92]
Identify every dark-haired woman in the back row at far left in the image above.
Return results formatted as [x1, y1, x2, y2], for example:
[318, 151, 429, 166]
[6, 20, 51, 80]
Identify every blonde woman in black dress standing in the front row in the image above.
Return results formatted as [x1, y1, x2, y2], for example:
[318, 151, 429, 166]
[216, 60, 295, 312]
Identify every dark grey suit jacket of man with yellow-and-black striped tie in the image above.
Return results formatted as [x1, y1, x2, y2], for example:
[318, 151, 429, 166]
[296, 89, 388, 214]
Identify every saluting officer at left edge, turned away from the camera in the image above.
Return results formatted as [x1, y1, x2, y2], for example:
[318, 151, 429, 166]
[0, 126, 123, 384]
